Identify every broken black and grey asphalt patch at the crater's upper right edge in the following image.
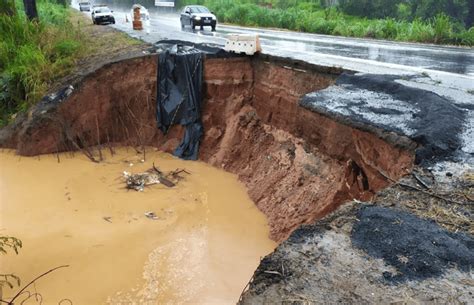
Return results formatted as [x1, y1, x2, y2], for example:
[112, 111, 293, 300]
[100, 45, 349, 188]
[300, 74, 467, 165]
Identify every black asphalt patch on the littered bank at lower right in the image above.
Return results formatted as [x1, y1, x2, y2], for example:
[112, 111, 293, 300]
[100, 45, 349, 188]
[351, 206, 474, 283]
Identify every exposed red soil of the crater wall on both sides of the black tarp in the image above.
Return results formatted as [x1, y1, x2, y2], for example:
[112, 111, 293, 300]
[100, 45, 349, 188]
[0, 55, 413, 240]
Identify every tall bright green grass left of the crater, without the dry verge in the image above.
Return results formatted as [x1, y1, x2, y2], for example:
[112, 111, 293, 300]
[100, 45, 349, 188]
[0, 0, 81, 126]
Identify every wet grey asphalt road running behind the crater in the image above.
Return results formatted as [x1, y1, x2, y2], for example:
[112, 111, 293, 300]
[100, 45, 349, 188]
[74, 2, 474, 85]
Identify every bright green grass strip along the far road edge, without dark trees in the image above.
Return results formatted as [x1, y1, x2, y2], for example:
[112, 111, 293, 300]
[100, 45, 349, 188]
[181, 0, 474, 46]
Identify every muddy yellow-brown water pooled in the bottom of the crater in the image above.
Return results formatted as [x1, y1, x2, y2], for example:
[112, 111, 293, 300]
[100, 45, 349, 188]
[0, 149, 276, 304]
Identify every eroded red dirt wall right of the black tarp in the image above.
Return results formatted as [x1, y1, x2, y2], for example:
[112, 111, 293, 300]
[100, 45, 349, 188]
[201, 60, 412, 240]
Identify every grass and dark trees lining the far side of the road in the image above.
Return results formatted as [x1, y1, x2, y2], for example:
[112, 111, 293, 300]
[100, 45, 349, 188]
[180, 0, 474, 46]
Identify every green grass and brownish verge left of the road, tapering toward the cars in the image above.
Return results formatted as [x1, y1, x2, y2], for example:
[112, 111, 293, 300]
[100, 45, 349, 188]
[0, 0, 139, 127]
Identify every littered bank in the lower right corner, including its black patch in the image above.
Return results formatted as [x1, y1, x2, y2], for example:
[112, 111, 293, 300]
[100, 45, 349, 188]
[241, 163, 474, 304]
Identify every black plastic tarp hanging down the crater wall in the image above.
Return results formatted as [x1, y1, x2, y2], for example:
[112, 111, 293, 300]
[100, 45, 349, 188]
[157, 45, 204, 160]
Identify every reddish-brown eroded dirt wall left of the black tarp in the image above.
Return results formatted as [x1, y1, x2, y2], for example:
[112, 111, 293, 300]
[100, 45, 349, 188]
[7, 56, 156, 156]
